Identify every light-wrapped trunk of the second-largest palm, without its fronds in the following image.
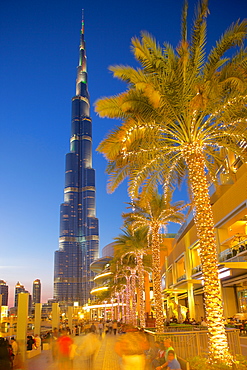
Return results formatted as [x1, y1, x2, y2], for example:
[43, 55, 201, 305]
[152, 223, 164, 332]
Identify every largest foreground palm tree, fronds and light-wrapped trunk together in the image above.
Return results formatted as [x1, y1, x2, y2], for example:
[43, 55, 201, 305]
[96, 0, 247, 364]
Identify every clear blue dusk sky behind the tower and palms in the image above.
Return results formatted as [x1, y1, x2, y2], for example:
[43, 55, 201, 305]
[0, 0, 247, 306]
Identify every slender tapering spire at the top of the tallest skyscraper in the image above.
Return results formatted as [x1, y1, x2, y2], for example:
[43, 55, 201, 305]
[76, 9, 87, 95]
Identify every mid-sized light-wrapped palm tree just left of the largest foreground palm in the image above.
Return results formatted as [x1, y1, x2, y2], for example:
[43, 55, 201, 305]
[123, 192, 184, 332]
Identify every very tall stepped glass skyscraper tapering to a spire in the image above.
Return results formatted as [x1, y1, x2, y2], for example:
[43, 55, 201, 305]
[54, 15, 99, 306]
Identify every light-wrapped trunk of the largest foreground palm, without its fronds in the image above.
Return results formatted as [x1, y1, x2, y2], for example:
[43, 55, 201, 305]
[185, 145, 232, 363]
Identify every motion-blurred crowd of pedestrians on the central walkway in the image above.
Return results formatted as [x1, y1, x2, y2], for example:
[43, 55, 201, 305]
[41, 320, 181, 370]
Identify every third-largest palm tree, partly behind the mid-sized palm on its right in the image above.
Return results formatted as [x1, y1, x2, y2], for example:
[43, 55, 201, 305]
[114, 226, 147, 327]
